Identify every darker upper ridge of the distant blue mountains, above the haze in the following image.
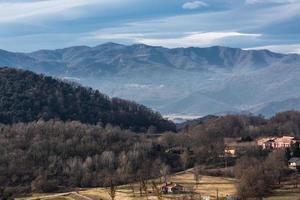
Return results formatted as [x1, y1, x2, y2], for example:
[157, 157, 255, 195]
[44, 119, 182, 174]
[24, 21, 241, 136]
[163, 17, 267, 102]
[0, 43, 300, 76]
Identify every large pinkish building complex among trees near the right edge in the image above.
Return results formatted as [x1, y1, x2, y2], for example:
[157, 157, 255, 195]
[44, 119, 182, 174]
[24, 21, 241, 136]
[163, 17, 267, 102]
[256, 136, 300, 149]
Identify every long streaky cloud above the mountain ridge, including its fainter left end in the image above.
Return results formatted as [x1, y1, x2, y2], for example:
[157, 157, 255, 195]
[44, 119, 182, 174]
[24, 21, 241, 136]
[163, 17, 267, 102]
[82, 29, 262, 48]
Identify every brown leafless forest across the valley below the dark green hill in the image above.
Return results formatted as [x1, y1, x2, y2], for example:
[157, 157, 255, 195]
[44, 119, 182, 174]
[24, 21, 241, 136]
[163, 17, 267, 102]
[0, 111, 300, 199]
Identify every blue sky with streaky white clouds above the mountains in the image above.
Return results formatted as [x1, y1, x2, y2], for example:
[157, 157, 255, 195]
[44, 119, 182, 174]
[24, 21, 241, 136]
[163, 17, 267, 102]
[0, 0, 300, 53]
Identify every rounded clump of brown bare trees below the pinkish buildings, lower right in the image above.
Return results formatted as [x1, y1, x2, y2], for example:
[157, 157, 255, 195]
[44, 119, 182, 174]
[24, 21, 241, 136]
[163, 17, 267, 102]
[234, 151, 290, 199]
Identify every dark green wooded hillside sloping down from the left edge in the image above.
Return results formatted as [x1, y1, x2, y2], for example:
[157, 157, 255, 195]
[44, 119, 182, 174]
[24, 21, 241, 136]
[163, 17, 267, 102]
[0, 68, 175, 132]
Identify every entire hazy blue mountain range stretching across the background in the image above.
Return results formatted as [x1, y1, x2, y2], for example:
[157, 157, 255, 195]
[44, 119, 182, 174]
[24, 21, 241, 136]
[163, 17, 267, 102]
[0, 43, 300, 116]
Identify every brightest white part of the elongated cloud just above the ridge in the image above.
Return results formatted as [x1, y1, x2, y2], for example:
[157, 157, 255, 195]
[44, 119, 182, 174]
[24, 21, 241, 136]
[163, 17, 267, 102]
[136, 32, 261, 47]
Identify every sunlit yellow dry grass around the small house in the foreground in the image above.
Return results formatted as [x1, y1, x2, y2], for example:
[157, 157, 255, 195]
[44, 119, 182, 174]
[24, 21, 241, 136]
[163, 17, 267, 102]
[15, 171, 236, 200]
